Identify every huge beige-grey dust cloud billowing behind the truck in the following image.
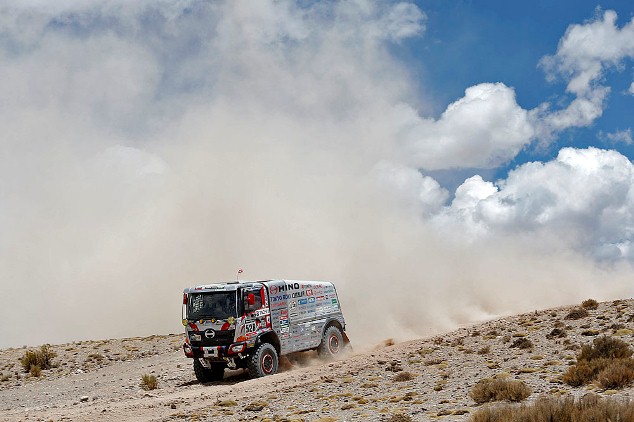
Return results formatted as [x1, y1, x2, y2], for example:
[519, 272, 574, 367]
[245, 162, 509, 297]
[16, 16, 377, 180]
[0, 2, 631, 347]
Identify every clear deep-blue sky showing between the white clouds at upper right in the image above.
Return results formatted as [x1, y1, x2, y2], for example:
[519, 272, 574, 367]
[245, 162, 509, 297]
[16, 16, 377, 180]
[414, 1, 634, 160]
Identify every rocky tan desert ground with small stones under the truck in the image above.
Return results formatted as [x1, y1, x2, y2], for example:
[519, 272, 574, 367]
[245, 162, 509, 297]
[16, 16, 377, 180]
[0, 300, 634, 422]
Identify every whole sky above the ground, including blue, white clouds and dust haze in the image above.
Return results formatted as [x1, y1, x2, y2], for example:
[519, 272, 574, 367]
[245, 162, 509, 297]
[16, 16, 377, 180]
[0, 0, 634, 346]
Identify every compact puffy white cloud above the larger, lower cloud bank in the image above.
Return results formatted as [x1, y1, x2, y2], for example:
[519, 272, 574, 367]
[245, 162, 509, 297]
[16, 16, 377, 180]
[395, 83, 534, 170]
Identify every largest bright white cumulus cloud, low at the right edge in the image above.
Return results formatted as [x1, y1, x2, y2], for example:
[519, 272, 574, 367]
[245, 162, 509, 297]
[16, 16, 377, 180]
[434, 148, 634, 259]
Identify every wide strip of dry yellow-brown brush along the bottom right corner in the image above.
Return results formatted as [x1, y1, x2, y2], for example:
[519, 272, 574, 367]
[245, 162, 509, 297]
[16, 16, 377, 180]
[470, 394, 634, 422]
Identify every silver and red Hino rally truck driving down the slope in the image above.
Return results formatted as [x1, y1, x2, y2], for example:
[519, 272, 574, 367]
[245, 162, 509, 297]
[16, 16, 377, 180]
[183, 280, 349, 382]
